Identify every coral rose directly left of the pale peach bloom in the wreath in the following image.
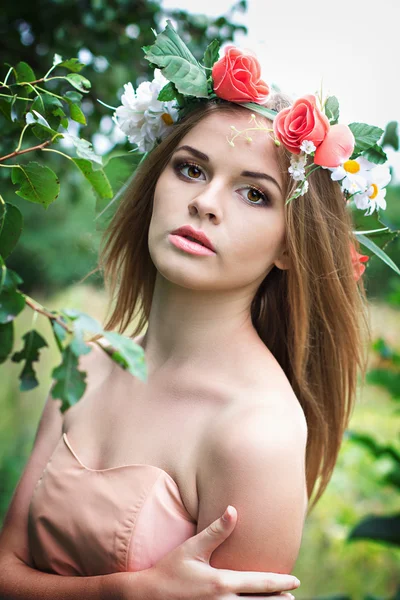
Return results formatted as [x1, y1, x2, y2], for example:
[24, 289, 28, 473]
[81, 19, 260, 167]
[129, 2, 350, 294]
[274, 94, 329, 154]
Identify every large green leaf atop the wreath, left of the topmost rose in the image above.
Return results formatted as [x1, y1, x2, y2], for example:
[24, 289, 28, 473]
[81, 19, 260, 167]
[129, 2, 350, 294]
[142, 20, 208, 98]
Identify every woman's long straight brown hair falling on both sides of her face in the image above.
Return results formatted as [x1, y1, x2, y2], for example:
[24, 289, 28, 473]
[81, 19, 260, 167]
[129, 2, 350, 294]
[86, 95, 370, 510]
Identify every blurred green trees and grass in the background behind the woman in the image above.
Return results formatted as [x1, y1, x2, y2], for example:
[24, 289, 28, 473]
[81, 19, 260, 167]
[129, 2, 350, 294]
[0, 0, 400, 599]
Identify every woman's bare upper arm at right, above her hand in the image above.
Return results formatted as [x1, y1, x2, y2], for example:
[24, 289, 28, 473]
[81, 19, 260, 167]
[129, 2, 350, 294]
[197, 394, 307, 573]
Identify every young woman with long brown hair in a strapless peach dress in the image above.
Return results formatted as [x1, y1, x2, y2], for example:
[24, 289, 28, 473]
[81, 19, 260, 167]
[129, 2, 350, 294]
[0, 27, 376, 600]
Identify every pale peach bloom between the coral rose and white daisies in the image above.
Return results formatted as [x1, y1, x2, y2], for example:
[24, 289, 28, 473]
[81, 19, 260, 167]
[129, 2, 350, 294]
[314, 125, 356, 168]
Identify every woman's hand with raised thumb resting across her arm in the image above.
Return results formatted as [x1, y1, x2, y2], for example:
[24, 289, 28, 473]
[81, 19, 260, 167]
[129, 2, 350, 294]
[123, 507, 300, 600]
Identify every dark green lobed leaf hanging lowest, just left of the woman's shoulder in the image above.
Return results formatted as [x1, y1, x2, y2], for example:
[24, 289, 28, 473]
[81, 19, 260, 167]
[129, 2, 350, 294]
[51, 345, 86, 412]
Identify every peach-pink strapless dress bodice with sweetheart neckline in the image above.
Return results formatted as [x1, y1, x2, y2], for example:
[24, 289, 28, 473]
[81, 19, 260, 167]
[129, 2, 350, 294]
[28, 433, 196, 577]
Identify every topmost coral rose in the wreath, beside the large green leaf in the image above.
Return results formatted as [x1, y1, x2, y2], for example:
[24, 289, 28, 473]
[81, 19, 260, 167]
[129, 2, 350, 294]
[212, 46, 269, 104]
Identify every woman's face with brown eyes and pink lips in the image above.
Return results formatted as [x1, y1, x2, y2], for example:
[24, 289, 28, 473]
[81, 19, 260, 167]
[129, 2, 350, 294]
[148, 111, 288, 293]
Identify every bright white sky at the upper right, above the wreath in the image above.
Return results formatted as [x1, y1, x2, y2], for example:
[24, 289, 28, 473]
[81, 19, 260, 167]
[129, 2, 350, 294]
[161, 0, 400, 179]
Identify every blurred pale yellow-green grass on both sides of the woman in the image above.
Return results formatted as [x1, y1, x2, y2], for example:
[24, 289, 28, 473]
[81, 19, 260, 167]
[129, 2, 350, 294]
[0, 285, 400, 600]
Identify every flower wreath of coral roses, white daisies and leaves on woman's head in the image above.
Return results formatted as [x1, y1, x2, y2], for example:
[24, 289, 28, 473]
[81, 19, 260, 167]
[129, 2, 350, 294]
[113, 21, 400, 279]
